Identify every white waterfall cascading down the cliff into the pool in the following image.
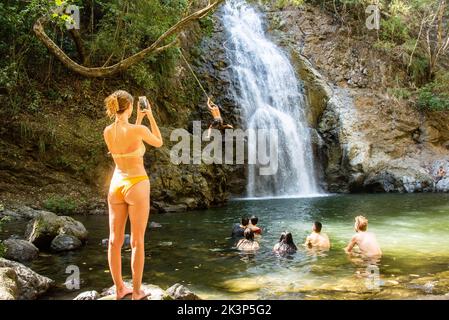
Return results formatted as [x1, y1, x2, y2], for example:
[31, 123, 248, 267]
[222, 0, 320, 197]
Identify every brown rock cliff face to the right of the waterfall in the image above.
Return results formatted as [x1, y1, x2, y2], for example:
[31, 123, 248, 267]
[261, 1, 449, 192]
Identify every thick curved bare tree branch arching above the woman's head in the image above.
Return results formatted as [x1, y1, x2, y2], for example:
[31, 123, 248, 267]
[33, 0, 224, 78]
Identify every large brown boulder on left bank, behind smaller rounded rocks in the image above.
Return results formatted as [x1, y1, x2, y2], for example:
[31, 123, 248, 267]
[25, 211, 88, 249]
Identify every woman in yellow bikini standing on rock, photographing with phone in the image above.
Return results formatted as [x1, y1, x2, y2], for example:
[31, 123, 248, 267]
[104, 90, 162, 300]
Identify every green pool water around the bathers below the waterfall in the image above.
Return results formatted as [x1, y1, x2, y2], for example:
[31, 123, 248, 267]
[2, 194, 449, 299]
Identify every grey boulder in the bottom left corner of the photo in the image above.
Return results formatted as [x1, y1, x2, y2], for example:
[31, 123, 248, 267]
[0, 258, 54, 300]
